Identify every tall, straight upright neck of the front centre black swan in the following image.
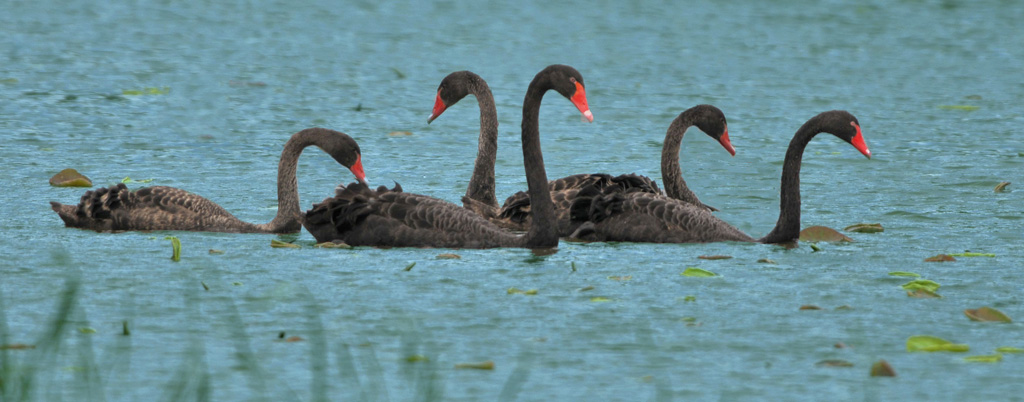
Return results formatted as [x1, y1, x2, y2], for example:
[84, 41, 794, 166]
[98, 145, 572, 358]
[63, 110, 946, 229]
[521, 82, 558, 245]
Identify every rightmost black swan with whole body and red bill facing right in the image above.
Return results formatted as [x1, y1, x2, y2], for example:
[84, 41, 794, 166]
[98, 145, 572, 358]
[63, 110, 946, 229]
[570, 110, 871, 243]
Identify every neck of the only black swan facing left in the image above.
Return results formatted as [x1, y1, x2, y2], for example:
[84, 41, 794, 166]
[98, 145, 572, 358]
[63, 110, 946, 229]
[466, 80, 498, 208]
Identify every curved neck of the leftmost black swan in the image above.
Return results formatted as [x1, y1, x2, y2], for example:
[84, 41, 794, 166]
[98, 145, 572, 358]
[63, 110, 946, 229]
[256, 129, 324, 233]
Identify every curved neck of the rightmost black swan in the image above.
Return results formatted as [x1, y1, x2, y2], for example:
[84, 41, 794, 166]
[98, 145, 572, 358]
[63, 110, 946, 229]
[758, 122, 821, 243]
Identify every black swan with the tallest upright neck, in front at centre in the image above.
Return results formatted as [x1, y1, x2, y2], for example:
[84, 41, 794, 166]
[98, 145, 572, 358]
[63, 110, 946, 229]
[303, 64, 593, 249]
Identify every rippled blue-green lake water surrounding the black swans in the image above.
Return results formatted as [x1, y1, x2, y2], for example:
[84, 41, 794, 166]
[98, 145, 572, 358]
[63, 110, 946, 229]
[0, 0, 1024, 401]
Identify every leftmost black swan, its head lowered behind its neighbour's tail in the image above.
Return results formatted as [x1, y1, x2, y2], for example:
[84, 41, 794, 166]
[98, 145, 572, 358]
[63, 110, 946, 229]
[50, 128, 366, 233]
